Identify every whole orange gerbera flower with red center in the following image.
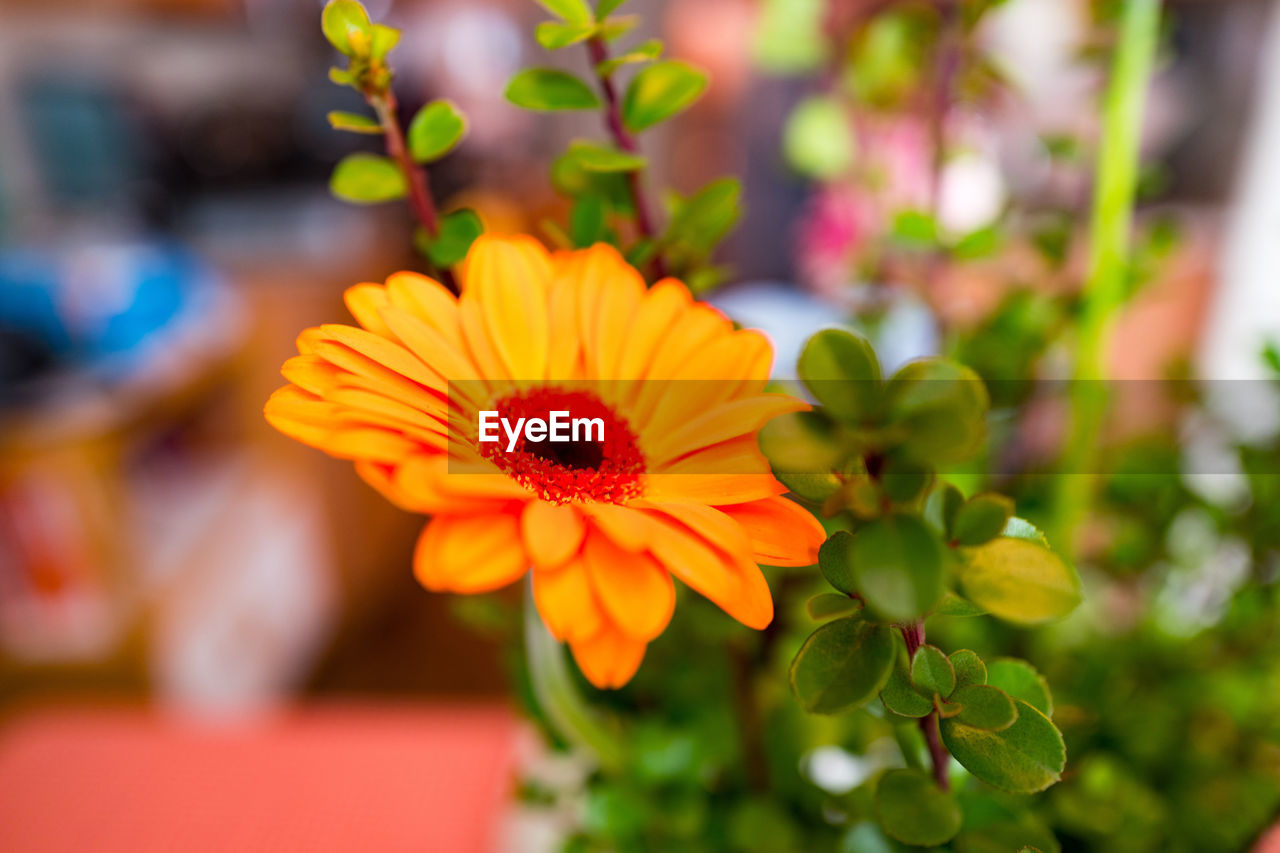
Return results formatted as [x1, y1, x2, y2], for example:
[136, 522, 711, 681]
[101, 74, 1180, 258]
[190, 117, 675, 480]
[266, 236, 823, 686]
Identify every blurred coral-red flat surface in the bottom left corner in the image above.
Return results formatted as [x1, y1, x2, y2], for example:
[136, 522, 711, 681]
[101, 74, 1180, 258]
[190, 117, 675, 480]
[0, 706, 516, 853]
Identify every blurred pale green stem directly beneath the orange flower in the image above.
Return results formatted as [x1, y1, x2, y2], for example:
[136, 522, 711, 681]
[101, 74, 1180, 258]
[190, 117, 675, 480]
[525, 578, 622, 772]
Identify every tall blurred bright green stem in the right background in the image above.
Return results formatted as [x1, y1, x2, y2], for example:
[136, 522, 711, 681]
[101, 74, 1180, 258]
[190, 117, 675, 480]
[1051, 0, 1160, 555]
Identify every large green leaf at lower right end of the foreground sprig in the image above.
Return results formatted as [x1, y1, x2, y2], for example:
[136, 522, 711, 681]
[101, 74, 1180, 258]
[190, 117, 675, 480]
[941, 699, 1066, 794]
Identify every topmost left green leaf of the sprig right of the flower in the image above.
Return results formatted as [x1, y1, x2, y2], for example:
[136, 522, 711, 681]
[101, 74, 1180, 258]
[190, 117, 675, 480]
[796, 329, 881, 425]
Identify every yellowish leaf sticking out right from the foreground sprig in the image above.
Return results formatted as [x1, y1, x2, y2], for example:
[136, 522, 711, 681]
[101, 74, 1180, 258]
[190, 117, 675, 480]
[960, 537, 1080, 625]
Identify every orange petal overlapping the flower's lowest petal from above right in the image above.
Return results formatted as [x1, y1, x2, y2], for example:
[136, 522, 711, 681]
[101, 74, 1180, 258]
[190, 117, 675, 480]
[582, 534, 676, 640]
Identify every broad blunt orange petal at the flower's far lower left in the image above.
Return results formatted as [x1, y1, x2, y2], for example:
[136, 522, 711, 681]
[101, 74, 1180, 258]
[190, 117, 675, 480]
[413, 512, 529, 593]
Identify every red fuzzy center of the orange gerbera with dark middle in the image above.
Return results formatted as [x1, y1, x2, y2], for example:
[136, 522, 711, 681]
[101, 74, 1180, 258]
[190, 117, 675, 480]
[480, 388, 644, 503]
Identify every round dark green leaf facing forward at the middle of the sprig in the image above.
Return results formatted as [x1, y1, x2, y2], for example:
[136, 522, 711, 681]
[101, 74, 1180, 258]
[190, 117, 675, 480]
[850, 514, 945, 622]
